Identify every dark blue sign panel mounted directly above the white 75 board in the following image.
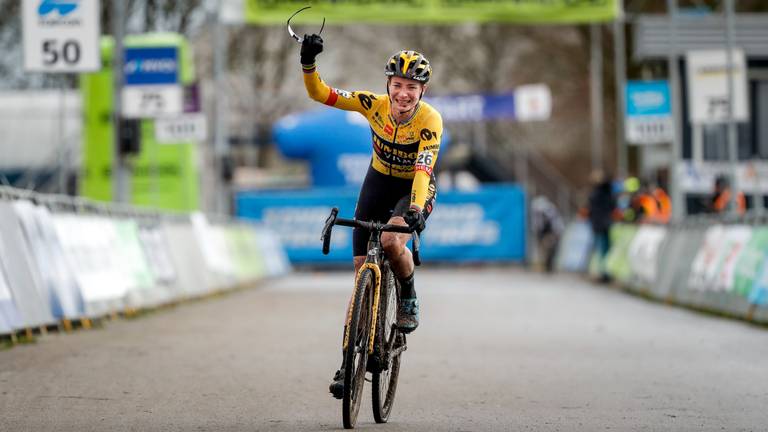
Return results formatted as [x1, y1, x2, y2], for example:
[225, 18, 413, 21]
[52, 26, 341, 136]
[123, 47, 179, 86]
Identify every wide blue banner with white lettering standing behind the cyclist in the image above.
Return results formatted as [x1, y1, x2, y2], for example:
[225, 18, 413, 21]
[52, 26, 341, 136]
[236, 185, 526, 264]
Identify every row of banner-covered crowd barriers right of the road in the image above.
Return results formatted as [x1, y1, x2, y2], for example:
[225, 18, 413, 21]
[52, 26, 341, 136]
[557, 216, 768, 324]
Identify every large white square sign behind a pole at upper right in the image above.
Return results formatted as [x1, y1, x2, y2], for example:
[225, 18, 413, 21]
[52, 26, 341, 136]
[686, 49, 749, 124]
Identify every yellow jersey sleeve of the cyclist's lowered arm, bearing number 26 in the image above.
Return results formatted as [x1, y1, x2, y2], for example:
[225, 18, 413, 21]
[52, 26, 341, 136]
[411, 112, 443, 209]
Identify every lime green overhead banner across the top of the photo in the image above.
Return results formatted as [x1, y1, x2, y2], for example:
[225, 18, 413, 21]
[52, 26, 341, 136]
[245, 0, 618, 24]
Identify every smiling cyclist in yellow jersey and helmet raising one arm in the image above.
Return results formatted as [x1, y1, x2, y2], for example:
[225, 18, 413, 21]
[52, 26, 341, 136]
[300, 34, 443, 399]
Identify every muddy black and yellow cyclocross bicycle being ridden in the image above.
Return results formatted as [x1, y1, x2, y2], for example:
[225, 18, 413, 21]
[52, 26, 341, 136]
[322, 208, 421, 429]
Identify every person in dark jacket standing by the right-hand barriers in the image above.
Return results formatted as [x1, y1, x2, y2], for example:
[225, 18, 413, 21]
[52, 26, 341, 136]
[588, 171, 616, 282]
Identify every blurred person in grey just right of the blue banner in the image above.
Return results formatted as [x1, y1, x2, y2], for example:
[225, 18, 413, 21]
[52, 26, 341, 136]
[531, 195, 565, 273]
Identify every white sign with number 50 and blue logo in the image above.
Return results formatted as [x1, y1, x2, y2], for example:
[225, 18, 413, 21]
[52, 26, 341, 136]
[22, 0, 101, 72]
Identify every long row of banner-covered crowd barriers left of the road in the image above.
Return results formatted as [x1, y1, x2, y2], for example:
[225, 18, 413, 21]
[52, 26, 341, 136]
[0, 187, 290, 335]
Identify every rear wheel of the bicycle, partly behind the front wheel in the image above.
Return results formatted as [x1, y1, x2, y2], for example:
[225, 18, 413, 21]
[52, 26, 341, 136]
[371, 271, 405, 423]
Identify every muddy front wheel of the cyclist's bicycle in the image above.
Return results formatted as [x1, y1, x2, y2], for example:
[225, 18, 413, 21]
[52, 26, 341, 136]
[342, 269, 376, 429]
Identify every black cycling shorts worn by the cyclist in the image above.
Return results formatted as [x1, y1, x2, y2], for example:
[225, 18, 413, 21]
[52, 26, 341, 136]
[352, 166, 437, 256]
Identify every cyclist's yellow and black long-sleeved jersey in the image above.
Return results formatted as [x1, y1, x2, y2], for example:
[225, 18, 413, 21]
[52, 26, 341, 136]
[304, 66, 443, 209]
